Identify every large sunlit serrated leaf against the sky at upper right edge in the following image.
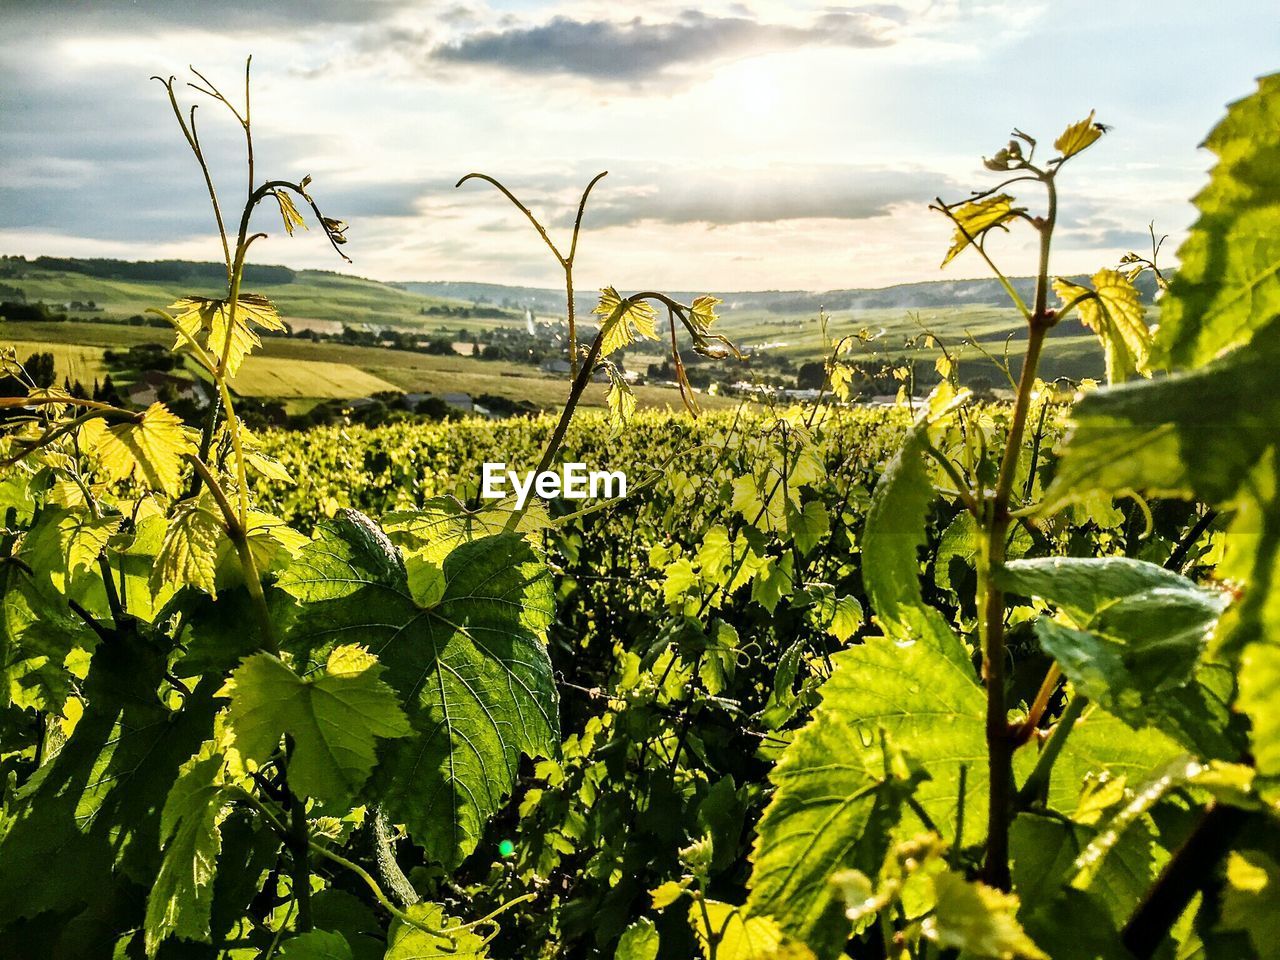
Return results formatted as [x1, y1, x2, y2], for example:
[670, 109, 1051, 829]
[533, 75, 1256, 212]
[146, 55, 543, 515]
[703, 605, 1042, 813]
[1153, 74, 1280, 368]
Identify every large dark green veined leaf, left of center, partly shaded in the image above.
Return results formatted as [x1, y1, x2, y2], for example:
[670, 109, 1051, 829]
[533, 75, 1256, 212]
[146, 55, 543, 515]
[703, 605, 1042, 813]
[279, 512, 559, 865]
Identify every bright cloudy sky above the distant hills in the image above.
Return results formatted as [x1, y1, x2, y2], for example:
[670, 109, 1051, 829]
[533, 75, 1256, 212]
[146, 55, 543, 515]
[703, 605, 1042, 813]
[0, 0, 1280, 291]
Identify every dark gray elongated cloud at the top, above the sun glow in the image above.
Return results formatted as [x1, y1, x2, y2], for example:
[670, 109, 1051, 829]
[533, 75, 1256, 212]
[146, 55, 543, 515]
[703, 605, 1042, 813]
[429, 5, 906, 82]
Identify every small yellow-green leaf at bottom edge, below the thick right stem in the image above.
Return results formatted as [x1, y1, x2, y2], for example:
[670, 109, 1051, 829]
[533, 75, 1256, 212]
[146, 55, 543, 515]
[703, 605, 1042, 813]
[923, 870, 1050, 960]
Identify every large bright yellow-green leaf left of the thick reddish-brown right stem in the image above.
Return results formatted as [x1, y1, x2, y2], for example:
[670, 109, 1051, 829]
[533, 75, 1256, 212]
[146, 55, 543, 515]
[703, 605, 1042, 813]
[748, 637, 987, 959]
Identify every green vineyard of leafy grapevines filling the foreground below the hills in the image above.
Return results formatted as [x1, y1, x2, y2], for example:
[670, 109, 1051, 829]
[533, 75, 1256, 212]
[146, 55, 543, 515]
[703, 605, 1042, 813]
[0, 56, 1280, 960]
